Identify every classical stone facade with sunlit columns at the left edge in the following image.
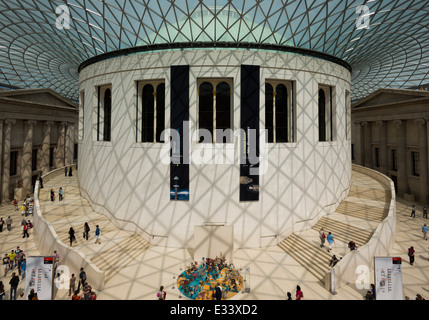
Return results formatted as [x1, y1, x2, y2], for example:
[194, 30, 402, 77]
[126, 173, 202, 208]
[0, 89, 78, 203]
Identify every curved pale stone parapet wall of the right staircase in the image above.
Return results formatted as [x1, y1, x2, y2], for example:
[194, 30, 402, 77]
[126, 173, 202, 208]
[325, 165, 396, 292]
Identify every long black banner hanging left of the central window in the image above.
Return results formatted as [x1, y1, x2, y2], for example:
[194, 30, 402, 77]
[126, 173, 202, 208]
[170, 66, 189, 201]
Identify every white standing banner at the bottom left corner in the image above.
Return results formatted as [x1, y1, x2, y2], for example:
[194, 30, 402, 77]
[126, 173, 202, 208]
[24, 257, 54, 300]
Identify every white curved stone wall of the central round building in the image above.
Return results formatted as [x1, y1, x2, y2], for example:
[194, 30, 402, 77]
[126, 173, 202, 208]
[78, 49, 351, 248]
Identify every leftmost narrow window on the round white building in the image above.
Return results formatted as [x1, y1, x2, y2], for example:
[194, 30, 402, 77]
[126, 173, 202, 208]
[96, 86, 112, 141]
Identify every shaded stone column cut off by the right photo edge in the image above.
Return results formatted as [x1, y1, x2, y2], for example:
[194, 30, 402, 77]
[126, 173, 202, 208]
[415, 119, 428, 203]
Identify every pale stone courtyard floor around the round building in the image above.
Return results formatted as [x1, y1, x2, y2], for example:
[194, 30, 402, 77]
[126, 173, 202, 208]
[0, 172, 429, 300]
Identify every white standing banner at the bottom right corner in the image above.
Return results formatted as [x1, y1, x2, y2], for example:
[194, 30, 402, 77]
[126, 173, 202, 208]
[374, 257, 403, 300]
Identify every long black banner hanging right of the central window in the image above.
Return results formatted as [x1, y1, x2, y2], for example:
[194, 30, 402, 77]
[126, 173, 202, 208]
[240, 65, 260, 201]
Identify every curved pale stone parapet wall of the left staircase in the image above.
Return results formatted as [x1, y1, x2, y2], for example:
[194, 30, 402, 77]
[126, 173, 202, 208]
[33, 165, 105, 290]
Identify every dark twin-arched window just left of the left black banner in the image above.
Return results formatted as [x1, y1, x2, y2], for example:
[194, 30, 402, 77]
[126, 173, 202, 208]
[136, 80, 165, 143]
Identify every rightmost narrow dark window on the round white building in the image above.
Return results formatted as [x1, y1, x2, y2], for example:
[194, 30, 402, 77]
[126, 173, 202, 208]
[318, 86, 335, 141]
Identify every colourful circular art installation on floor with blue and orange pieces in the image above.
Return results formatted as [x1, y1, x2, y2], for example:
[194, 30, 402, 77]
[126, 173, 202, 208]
[177, 257, 243, 300]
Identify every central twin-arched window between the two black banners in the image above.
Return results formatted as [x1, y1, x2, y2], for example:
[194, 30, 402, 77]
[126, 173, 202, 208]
[198, 79, 233, 143]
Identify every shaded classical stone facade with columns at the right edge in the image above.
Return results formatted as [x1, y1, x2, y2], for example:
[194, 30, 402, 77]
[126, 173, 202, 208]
[352, 89, 429, 204]
